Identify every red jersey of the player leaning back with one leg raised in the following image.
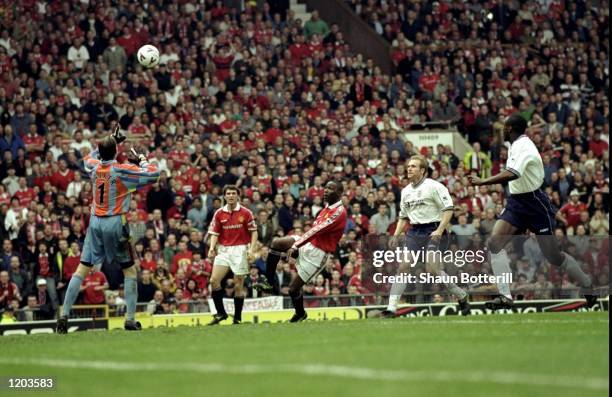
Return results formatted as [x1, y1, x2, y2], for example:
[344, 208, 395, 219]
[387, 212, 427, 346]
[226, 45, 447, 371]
[295, 201, 347, 254]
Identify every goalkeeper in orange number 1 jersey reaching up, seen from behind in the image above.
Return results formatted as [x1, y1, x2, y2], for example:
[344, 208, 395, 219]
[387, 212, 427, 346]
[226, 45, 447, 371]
[57, 124, 160, 334]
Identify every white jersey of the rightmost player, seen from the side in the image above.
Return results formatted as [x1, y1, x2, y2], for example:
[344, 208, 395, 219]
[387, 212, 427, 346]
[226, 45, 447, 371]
[506, 135, 544, 194]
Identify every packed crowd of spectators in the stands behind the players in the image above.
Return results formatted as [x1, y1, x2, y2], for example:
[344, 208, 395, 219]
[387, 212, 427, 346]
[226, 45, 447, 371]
[0, 0, 609, 318]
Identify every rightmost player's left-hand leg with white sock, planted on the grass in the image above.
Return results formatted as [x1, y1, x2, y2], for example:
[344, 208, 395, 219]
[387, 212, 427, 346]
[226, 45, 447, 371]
[485, 219, 518, 310]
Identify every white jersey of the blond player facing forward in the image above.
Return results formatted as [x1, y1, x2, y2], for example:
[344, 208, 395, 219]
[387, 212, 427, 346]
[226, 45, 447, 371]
[400, 178, 454, 224]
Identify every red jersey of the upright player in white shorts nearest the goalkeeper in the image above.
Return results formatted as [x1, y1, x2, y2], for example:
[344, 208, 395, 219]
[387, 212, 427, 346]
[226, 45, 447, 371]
[208, 204, 257, 246]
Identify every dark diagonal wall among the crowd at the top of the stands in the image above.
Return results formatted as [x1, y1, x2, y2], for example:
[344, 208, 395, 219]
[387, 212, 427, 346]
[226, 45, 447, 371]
[306, 0, 391, 74]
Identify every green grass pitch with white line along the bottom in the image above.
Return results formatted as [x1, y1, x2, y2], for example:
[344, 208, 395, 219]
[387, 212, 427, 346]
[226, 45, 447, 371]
[0, 313, 608, 397]
